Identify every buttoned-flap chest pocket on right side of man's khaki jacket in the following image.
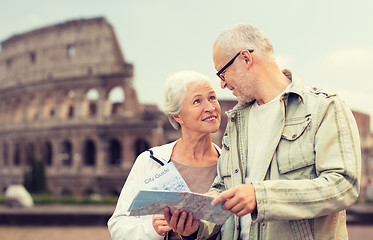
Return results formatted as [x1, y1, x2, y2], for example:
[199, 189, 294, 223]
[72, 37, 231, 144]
[276, 115, 315, 179]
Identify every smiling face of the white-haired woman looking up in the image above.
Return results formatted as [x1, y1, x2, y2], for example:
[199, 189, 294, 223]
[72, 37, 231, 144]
[174, 82, 221, 133]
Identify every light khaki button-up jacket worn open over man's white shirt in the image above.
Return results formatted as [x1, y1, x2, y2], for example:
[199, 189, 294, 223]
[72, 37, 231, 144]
[193, 70, 361, 240]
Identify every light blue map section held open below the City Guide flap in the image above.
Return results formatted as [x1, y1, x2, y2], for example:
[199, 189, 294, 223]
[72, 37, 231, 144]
[128, 190, 232, 225]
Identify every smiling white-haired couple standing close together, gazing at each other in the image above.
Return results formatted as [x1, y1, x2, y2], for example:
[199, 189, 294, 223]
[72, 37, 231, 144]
[108, 24, 361, 240]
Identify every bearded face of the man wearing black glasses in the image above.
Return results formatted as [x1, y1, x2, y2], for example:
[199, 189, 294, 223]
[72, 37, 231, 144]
[213, 46, 254, 103]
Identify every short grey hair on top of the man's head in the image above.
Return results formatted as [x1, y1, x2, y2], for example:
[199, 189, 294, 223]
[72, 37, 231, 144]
[214, 24, 274, 59]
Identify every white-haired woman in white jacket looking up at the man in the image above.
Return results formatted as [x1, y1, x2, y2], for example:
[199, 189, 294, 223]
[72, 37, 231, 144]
[108, 71, 221, 240]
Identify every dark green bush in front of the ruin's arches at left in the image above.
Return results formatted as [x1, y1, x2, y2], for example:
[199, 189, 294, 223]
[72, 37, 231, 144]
[24, 157, 47, 193]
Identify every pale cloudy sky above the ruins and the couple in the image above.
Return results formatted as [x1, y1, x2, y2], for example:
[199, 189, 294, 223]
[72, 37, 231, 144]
[0, 0, 373, 128]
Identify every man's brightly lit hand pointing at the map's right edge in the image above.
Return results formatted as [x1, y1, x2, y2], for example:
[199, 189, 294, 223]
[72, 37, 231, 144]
[211, 184, 256, 217]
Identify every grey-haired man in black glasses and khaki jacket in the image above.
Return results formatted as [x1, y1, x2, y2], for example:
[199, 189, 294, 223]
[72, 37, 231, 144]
[165, 24, 361, 240]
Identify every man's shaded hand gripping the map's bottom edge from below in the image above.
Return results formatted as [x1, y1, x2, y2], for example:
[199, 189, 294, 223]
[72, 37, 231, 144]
[164, 207, 199, 236]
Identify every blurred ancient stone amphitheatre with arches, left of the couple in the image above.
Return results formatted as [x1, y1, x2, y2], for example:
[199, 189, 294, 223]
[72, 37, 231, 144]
[0, 18, 178, 195]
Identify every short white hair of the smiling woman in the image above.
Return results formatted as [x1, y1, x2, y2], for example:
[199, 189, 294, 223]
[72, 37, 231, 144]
[163, 71, 211, 129]
